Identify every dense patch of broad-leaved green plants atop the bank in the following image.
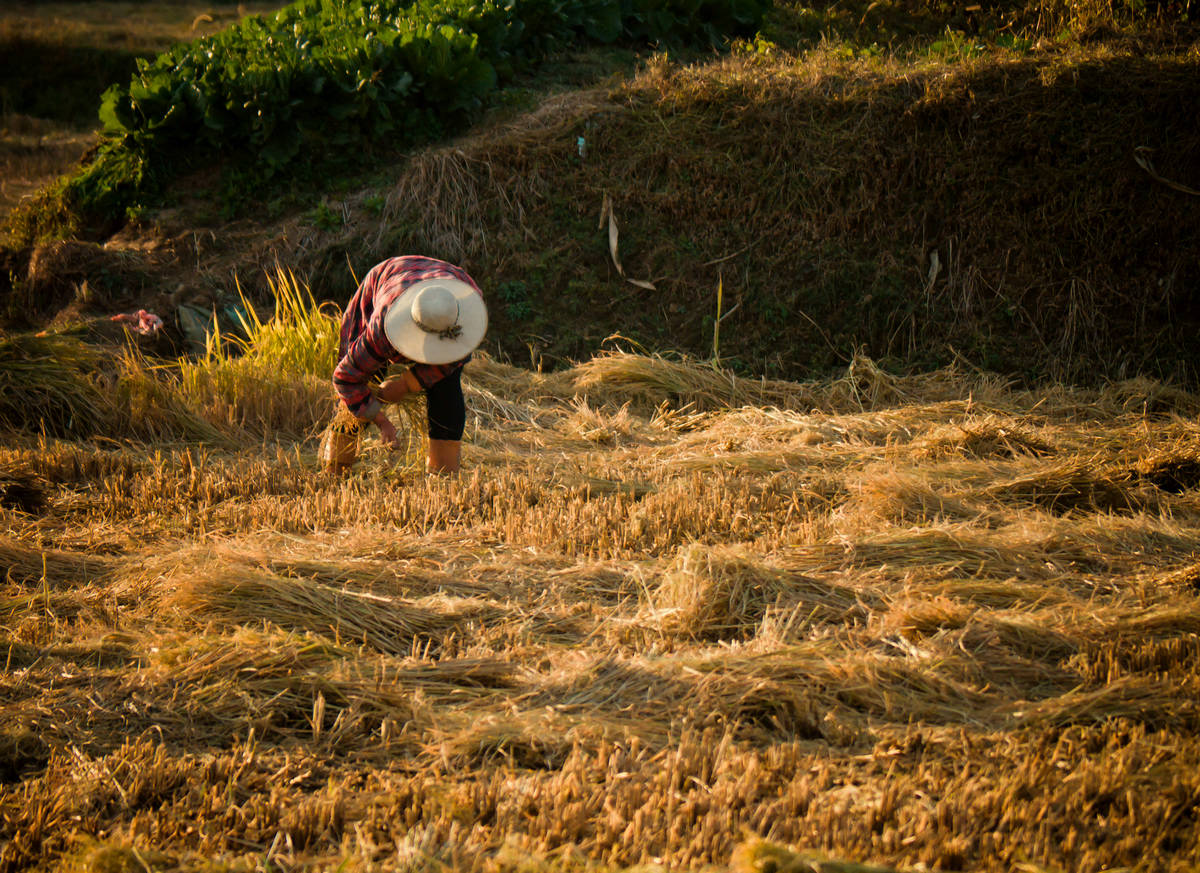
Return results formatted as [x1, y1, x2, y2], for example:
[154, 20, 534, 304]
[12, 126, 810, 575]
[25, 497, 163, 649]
[66, 0, 770, 226]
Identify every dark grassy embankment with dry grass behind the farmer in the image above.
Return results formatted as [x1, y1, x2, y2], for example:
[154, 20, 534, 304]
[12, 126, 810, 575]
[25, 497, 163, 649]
[0, 4, 1200, 385]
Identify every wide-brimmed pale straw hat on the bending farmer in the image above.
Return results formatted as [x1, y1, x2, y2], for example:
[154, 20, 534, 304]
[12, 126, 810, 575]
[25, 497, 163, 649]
[383, 277, 487, 363]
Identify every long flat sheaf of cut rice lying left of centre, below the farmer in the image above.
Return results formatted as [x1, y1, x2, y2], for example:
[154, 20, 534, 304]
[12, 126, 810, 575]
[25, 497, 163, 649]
[168, 564, 497, 655]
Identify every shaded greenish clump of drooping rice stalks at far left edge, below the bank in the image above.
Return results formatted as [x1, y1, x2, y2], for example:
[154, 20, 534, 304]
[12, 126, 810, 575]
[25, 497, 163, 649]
[0, 336, 113, 437]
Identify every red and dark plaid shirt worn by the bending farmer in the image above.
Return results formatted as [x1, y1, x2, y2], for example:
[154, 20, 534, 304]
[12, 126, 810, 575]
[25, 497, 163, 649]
[334, 255, 482, 421]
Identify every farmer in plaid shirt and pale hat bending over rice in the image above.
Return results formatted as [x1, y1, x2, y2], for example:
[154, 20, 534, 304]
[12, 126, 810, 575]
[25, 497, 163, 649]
[326, 255, 487, 472]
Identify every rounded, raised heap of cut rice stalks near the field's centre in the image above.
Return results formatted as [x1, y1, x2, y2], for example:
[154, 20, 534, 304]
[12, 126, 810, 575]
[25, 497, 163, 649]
[649, 543, 862, 639]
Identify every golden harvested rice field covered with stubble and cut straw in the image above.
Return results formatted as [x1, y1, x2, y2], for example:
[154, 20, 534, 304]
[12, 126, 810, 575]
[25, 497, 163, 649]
[0, 351, 1200, 873]
